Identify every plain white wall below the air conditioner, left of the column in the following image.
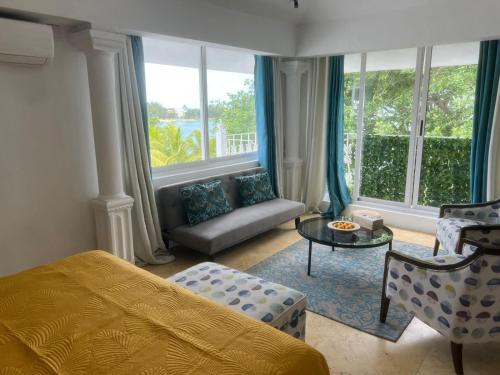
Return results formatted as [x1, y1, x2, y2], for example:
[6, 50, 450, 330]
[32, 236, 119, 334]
[0, 28, 98, 275]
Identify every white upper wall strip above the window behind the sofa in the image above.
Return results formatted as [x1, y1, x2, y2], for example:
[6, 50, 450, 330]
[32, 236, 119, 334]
[0, 0, 295, 56]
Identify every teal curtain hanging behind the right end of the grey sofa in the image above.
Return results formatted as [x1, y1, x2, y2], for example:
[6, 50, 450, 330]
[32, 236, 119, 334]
[255, 56, 277, 194]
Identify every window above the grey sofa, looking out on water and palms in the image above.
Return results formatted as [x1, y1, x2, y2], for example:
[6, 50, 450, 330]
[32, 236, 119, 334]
[143, 38, 257, 168]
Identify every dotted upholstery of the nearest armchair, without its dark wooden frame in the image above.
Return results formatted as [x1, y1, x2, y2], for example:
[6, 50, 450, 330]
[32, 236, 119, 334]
[385, 255, 500, 343]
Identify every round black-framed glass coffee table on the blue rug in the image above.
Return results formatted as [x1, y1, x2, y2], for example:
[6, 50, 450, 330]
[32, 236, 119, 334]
[297, 217, 393, 276]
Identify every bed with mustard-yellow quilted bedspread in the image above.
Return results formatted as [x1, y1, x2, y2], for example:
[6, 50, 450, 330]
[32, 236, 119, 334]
[0, 251, 329, 375]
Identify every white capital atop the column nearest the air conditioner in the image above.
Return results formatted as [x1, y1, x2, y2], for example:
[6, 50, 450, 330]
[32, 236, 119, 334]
[70, 29, 127, 54]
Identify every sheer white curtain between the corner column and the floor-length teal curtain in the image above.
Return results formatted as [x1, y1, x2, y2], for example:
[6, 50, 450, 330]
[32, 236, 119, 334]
[301, 57, 328, 212]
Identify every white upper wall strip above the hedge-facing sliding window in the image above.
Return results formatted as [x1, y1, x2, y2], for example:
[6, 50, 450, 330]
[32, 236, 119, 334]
[296, 0, 500, 56]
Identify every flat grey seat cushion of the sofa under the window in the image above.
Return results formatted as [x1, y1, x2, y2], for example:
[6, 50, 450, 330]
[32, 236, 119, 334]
[169, 199, 305, 254]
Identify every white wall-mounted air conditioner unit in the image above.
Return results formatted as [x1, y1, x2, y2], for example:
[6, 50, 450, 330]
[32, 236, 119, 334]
[0, 18, 54, 66]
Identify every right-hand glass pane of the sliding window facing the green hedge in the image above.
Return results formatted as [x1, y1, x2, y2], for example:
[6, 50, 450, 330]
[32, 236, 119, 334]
[415, 43, 479, 206]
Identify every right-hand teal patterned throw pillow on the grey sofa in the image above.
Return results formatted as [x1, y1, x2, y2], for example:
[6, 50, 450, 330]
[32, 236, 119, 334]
[236, 172, 276, 206]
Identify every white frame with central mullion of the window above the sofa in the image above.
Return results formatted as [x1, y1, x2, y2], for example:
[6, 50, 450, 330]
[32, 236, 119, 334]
[146, 45, 259, 173]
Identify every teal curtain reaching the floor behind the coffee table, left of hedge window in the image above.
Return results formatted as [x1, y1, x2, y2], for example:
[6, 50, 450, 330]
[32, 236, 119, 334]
[323, 56, 351, 216]
